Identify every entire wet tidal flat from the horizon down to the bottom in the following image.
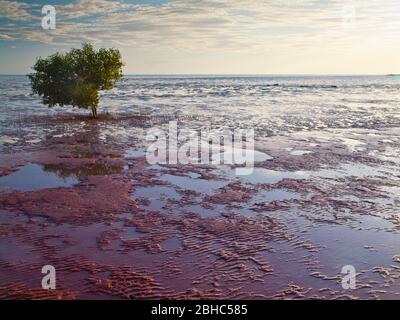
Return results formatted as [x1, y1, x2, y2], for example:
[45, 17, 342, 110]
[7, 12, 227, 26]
[0, 77, 400, 299]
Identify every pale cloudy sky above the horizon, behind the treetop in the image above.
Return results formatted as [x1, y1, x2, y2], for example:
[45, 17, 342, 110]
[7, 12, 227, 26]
[0, 0, 400, 74]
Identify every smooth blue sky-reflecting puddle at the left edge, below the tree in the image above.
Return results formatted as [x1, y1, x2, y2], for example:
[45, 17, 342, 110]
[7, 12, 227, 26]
[0, 163, 79, 191]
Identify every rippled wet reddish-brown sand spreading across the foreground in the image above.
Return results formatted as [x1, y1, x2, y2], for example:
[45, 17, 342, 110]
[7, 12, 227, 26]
[0, 121, 400, 299]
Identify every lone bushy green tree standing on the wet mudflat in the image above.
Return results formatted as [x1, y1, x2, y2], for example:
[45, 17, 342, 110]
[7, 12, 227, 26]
[29, 44, 123, 117]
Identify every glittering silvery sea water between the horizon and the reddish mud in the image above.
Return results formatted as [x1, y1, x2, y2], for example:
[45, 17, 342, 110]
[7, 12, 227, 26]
[0, 76, 400, 135]
